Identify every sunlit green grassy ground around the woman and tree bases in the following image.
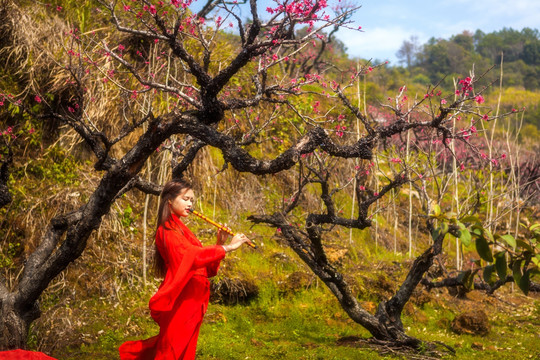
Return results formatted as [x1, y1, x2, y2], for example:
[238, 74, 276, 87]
[34, 246, 540, 360]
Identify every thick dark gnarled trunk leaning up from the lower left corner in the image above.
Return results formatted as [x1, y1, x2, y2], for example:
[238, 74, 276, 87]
[0, 118, 177, 349]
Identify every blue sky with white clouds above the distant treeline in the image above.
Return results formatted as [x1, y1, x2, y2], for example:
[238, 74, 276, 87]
[193, 0, 540, 65]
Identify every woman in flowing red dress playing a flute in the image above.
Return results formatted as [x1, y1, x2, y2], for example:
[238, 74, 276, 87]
[119, 179, 249, 360]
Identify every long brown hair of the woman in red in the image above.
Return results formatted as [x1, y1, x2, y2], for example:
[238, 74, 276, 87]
[154, 179, 192, 278]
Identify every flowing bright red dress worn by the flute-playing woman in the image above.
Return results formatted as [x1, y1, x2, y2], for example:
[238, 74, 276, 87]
[119, 214, 225, 360]
